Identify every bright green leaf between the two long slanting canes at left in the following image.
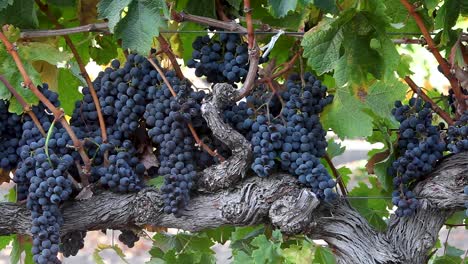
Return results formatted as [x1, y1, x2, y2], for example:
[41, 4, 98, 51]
[58, 68, 83, 116]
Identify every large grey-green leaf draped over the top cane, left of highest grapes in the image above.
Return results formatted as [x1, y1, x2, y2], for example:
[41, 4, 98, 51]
[115, 0, 167, 55]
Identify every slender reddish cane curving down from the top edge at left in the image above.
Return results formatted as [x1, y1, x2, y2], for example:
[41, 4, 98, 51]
[35, 0, 107, 153]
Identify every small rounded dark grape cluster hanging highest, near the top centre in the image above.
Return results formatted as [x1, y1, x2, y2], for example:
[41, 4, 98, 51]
[187, 33, 266, 84]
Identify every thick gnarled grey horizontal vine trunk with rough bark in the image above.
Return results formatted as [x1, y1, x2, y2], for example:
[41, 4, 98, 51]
[0, 152, 468, 263]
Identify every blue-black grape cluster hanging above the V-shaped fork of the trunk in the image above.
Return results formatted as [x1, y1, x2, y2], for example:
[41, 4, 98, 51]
[388, 98, 446, 216]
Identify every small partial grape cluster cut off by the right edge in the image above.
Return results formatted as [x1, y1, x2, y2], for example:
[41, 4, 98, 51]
[447, 111, 468, 153]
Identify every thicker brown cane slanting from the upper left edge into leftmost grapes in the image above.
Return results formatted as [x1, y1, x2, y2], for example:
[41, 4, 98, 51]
[0, 31, 91, 186]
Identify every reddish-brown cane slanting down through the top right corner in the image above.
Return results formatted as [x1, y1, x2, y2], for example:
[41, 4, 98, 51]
[400, 0, 466, 113]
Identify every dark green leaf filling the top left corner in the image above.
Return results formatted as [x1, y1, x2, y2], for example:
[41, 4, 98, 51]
[0, 0, 39, 28]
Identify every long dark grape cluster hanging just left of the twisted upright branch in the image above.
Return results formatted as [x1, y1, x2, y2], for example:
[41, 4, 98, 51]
[144, 73, 200, 216]
